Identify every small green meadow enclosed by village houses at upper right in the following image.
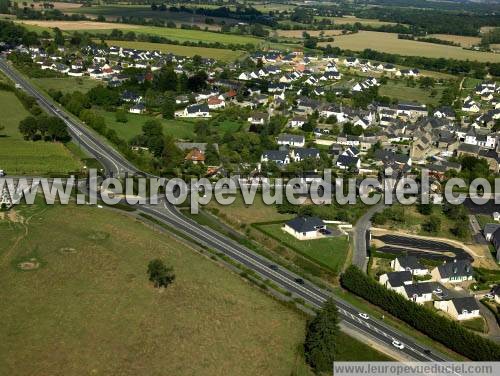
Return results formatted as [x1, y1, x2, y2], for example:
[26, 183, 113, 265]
[379, 80, 444, 105]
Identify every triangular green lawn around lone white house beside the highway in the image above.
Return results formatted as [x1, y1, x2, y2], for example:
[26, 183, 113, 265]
[257, 223, 349, 274]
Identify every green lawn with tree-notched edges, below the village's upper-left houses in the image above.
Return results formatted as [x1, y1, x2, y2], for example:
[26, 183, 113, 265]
[99, 111, 194, 141]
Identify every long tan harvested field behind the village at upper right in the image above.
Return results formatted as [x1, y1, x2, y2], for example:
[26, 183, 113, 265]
[320, 31, 500, 62]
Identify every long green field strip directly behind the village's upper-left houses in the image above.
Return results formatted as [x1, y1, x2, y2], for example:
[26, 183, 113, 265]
[102, 40, 245, 61]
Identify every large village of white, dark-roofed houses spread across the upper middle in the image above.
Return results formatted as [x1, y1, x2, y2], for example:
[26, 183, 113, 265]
[9, 46, 500, 179]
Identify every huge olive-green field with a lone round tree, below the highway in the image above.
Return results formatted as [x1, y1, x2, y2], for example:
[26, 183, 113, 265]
[0, 204, 387, 376]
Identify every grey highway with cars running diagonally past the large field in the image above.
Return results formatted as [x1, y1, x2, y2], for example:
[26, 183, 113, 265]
[0, 58, 449, 361]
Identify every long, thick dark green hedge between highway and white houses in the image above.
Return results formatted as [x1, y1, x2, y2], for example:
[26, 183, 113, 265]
[341, 265, 500, 361]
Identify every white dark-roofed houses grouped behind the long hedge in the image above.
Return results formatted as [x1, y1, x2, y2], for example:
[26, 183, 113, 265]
[379, 255, 481, 321]
